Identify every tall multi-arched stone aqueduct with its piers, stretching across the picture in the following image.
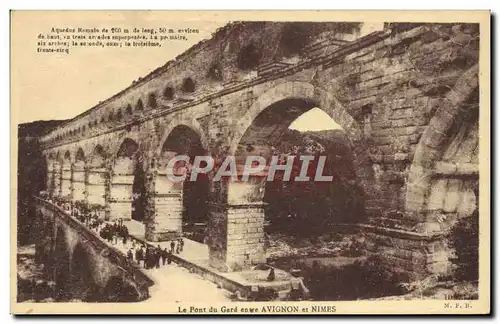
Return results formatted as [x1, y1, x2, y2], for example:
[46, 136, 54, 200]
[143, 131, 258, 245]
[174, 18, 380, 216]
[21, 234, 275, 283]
[37, 22, 479, 274]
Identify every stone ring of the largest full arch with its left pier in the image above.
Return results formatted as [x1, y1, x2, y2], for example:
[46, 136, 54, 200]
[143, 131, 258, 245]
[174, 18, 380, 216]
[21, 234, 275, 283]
[209, 81, 372, 271]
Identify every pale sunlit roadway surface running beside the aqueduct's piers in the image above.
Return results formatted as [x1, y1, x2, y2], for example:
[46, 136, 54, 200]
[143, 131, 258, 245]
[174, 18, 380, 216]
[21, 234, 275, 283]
[37, 199, 291, 302]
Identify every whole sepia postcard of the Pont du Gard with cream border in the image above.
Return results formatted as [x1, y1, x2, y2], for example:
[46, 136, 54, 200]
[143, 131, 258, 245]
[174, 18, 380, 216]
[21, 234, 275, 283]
[11, 11, 491, 315]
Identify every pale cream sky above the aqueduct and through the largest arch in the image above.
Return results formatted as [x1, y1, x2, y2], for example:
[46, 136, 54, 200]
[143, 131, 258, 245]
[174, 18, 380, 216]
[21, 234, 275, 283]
[11, 11, 380, 129]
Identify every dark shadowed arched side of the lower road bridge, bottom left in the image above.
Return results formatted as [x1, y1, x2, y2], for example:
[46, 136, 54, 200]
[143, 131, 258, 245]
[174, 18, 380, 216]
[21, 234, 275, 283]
[34, 198, 154, 302]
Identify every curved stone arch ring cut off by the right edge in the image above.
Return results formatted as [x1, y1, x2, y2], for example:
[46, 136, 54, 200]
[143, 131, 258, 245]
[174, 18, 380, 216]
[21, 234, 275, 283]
[406, 64, 479, 215]
